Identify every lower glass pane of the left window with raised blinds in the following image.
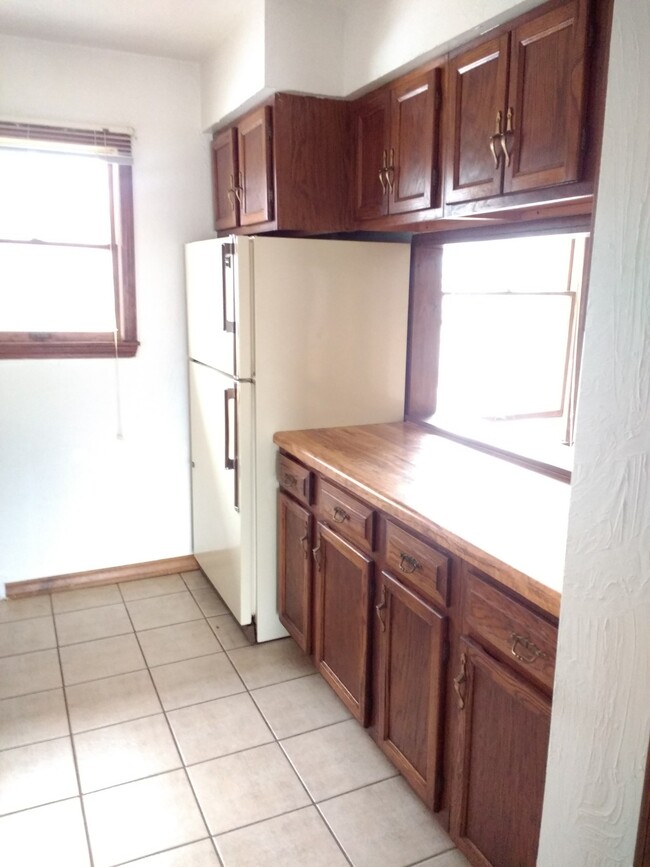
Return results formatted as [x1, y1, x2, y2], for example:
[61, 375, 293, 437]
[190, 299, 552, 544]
[0, 244, 115, 332]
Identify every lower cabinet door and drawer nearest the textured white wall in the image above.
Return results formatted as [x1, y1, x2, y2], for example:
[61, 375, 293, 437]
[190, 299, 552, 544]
[451, 570, 557, 867]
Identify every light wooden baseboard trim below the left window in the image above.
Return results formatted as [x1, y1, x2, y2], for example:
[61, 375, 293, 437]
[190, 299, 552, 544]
[5, 554, 199, 599]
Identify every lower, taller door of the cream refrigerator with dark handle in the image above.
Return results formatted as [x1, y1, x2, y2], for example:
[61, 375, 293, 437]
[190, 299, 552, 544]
[190, 362, 253, 625]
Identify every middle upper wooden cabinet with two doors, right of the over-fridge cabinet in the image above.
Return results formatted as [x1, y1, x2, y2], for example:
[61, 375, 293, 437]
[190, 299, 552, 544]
[353, 67, 440, 221]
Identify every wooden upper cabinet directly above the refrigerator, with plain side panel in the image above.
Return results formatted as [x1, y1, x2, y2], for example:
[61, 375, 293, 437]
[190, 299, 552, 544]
[212, 93, 352, 234]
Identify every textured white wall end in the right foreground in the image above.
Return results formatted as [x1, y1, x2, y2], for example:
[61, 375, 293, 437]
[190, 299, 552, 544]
[538, 0, 650, 867]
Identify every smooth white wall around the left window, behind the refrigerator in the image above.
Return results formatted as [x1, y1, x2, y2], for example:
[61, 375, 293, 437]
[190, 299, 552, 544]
[0, 37, 211, 589]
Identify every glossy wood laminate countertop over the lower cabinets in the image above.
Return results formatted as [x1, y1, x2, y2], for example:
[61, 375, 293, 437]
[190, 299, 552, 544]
[273, 422, 570, 617]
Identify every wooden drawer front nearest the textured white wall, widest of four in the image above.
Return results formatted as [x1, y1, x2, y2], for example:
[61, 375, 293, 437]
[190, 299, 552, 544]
[465, 573, 557, 690]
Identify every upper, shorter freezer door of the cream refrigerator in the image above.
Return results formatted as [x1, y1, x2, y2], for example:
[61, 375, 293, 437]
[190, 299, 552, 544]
[185, 238, 244, 376]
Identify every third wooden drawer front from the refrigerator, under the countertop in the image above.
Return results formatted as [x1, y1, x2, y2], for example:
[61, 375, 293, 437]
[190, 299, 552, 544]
[385, 521, 449, 606]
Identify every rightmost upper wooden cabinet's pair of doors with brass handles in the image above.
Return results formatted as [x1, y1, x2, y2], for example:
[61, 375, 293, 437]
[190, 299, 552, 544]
[445, 0, 589, 206]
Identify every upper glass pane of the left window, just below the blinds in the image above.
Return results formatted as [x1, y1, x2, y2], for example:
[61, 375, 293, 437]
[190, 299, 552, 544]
[0, 150, 111, 244]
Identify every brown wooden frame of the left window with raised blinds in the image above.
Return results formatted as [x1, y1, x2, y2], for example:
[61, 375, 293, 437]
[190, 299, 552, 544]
[0, 121, 139, 359]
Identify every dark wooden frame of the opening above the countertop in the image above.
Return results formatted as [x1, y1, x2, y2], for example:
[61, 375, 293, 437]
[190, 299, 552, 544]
[404, 215, 592, 482]
